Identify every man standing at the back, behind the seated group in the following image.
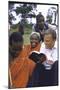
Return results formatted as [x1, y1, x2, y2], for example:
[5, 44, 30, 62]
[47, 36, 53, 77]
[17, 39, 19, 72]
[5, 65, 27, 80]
[34, 13, 48, 41]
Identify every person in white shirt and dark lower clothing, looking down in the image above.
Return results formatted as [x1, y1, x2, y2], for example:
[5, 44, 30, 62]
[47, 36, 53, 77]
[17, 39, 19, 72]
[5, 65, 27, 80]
[28, 29, 58, 87]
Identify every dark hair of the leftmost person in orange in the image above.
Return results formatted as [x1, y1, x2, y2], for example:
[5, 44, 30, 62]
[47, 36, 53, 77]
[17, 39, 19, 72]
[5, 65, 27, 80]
[9, 32, 23, 45]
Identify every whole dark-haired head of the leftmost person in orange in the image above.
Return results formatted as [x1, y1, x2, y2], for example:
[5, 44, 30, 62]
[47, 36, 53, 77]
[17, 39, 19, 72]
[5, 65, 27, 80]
[9, 32, 23, 57]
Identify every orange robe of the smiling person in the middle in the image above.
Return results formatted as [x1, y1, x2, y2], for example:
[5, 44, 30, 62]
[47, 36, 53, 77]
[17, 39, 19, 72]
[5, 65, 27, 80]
[25, 43, 41, 76]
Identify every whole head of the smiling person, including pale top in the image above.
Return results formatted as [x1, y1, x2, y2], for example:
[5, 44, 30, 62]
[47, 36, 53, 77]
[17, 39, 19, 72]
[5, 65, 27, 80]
[30, 32, 40, 48]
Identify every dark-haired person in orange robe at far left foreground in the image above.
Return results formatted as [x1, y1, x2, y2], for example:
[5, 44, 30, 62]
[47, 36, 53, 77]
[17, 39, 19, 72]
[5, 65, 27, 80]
[8, 32, 37, 88]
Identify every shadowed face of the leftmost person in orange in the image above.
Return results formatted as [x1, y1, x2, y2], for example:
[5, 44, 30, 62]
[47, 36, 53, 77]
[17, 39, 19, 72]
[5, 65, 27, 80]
[10, 41, 23, 57]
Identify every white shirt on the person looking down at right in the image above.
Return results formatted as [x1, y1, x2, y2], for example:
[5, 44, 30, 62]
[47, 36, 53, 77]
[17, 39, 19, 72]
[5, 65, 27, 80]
[40, 43, 58, 62]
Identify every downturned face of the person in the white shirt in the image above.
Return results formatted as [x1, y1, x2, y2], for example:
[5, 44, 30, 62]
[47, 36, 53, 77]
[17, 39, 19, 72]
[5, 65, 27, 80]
[44, 34, 55, 49]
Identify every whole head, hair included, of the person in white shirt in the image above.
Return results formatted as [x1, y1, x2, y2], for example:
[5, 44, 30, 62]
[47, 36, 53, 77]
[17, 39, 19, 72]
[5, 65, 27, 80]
[44, 29, 56, 49]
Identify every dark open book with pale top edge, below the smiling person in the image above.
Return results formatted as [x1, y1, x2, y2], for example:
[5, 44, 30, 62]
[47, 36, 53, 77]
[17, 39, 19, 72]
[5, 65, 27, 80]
[29, 51, 46, 63]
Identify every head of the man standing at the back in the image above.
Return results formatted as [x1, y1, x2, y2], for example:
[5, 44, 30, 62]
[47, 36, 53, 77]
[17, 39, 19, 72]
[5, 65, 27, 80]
[36, 13, 45, 30]
